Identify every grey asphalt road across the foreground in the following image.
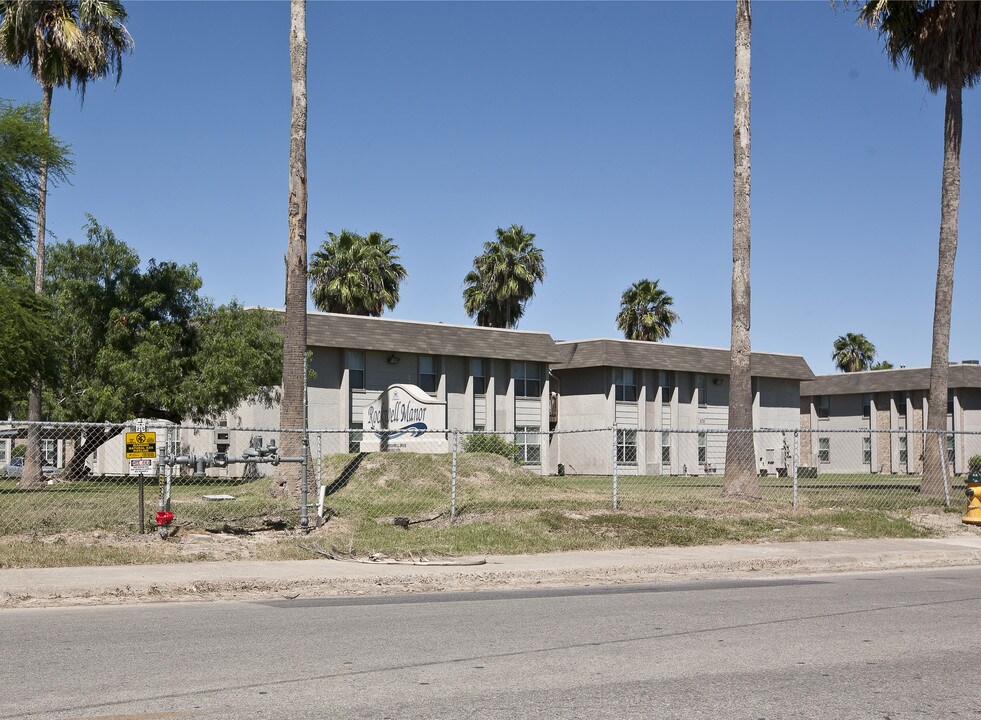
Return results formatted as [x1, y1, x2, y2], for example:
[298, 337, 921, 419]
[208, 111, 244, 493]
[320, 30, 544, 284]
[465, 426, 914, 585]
[0, 568, 981, 720]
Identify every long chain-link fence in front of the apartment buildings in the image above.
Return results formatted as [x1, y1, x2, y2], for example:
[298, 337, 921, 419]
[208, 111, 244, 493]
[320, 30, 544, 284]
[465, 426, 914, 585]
[0, 422, 981, 538]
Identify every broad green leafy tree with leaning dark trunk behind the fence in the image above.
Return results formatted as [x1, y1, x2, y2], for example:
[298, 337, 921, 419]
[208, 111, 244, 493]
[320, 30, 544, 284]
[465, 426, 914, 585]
[44, 217, 282, 477]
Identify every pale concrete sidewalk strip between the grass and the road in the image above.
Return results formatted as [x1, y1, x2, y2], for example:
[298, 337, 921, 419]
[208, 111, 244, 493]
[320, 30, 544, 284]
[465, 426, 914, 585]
[0, 535, 981, 608]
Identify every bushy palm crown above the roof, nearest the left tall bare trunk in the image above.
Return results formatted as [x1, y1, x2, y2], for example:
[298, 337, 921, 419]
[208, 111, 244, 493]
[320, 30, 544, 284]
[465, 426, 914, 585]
[310, 230, 407, 317]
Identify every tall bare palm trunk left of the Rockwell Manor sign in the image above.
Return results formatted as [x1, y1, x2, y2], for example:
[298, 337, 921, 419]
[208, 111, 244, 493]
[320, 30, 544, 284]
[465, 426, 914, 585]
[273, 0, 307, 497]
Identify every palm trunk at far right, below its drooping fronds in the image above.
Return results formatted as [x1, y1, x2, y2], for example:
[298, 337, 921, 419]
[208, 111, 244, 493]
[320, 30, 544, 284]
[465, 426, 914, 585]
[920, 80, 963, 497]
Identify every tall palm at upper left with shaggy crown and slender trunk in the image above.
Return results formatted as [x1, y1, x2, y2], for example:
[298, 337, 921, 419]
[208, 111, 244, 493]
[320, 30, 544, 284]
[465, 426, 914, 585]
[0, 0, 133, 485]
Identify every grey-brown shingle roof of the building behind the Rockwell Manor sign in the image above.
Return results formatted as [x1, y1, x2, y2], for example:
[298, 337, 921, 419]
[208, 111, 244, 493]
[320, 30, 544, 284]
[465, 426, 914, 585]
[296, 313, 564, 363]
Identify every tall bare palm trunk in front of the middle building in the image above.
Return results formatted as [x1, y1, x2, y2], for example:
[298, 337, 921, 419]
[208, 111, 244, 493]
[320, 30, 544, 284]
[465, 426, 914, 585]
[724, 0, 760, 498]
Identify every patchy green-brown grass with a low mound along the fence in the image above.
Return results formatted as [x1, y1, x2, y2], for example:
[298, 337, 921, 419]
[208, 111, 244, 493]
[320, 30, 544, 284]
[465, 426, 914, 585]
[0, 453, 964, 567]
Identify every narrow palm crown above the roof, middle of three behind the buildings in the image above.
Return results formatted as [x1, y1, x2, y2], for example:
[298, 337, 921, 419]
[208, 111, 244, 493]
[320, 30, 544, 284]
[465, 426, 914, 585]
[463, 225, 545, 328]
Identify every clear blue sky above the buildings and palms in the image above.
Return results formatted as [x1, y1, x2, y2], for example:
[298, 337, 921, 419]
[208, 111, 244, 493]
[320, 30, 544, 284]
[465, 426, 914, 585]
[0, 2, 981, 373]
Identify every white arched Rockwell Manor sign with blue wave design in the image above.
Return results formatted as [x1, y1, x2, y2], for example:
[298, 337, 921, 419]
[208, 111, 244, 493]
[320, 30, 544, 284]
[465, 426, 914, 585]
[361, 384, 449, 453]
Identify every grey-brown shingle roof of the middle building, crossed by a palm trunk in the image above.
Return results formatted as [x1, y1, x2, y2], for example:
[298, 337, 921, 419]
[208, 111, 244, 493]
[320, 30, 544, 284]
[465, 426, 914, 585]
[556, 339, 814, 380]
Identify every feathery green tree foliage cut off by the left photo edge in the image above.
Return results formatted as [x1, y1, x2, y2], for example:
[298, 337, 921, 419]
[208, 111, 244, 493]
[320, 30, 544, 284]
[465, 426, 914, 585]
[0, 101, 72, 417]
